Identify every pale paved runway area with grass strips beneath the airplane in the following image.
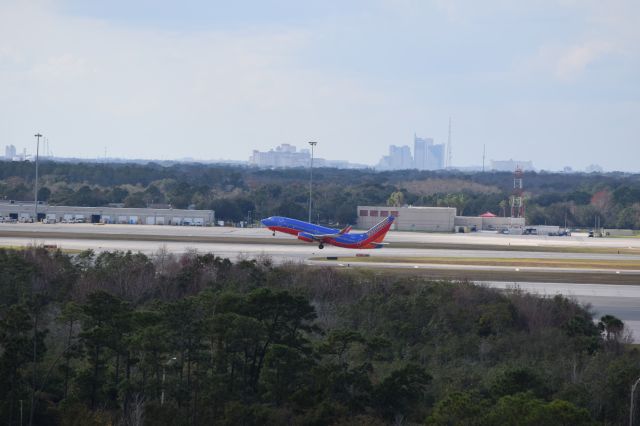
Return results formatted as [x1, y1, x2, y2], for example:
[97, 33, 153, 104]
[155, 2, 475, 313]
[0, 224, 640, 342]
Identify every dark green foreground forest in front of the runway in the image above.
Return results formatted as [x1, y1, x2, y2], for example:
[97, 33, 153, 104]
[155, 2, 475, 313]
[0, 247, 640, 425]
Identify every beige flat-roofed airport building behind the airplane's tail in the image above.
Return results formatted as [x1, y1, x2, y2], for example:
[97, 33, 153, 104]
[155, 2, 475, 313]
[357, 206, 524, 233]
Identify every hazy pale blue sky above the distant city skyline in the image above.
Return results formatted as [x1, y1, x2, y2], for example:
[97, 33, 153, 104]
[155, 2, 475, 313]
[0, 0, 640, 172]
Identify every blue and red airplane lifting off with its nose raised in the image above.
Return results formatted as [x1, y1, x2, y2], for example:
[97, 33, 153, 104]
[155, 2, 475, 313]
[260, 216, 396, 249]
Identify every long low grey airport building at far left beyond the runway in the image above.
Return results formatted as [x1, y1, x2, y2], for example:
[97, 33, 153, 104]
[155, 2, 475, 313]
[0, 201, 215, 226]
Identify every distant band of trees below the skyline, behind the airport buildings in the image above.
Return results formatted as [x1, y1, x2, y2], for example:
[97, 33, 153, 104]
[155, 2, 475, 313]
[0, 161, 640, 230]
